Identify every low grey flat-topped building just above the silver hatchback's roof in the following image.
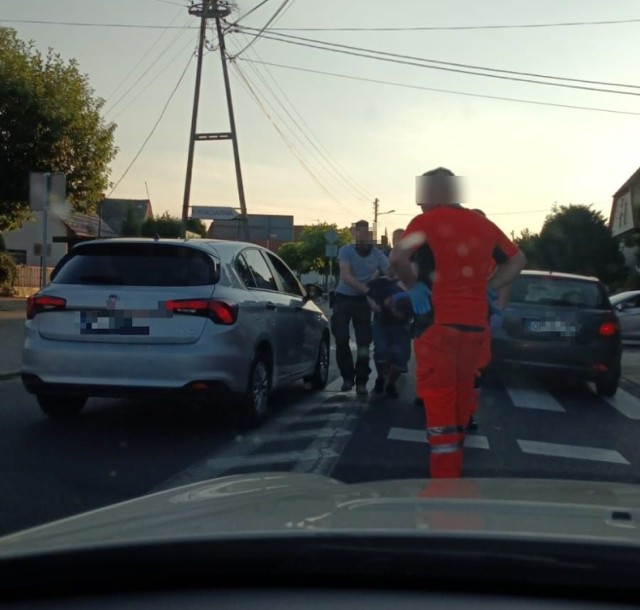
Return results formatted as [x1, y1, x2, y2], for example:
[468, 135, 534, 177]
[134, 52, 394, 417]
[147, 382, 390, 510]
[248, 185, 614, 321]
[207, 214, 294, 251]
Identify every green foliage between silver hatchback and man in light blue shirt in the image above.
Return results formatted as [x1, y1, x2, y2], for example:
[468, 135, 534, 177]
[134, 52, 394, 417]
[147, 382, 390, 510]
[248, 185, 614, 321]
[278, 222, 351, 273]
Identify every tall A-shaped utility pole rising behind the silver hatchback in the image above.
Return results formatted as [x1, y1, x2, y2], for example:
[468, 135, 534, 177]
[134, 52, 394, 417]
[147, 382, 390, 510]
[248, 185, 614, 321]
[182, 0, 249, 240]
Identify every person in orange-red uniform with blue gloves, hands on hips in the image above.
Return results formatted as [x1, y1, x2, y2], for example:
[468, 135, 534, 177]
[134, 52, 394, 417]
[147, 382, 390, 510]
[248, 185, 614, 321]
[390, 167, 526, 478]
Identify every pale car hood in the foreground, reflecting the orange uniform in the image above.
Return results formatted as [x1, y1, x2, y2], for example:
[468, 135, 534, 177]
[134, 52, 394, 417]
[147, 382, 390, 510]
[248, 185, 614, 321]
[0, 473, 640, 557]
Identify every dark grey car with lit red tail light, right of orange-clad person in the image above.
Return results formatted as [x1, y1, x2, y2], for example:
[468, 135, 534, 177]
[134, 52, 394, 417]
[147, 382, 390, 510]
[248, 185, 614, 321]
[492, 271, 622, 396]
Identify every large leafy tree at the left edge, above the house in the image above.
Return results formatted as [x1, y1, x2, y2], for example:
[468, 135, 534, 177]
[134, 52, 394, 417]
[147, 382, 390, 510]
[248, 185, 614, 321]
[0, 27, 117, 231]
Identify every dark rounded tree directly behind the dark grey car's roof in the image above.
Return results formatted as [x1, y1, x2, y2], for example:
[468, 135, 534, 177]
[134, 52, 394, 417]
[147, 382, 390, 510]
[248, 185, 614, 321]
[525, 205, 628, 286]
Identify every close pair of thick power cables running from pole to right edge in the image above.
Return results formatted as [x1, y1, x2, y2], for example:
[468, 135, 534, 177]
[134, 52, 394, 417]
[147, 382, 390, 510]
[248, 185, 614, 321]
[236, 27, 640, 96]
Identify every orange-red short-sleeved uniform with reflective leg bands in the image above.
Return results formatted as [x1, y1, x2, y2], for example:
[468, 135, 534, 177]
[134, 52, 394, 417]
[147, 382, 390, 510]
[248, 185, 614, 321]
[403, 206, 518, 478]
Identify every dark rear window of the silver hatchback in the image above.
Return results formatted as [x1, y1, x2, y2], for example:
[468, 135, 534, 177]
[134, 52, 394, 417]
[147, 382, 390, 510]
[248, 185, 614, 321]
[52, 242, 218, 286]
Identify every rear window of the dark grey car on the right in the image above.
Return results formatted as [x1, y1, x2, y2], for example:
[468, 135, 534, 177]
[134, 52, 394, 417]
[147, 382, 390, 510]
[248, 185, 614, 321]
[509, 275, 610, 309]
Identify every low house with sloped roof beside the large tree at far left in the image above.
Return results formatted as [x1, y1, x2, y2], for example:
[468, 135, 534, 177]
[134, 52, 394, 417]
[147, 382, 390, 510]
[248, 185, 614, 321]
[2, 205, 116, 267]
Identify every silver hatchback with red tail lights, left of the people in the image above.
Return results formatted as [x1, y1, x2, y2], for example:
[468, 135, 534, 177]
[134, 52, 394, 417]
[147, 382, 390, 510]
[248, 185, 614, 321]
[21, 239, 330, 425]
